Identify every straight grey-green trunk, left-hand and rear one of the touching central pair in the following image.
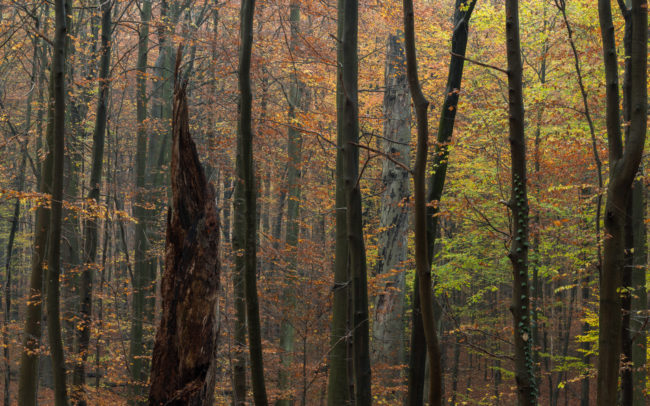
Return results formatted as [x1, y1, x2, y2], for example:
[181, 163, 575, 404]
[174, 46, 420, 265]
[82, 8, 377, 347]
[327, 0, 351, 406]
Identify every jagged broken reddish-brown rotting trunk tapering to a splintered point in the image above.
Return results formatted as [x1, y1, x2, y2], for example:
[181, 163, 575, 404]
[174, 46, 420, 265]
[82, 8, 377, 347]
[149, 54, 220, 406]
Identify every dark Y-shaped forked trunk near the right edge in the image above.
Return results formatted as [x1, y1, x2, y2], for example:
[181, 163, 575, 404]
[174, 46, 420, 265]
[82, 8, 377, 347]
[597, 0, 648, 406]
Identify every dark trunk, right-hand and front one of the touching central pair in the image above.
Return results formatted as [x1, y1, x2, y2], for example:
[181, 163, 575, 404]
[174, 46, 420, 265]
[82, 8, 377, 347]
[338, 0, 372, 406]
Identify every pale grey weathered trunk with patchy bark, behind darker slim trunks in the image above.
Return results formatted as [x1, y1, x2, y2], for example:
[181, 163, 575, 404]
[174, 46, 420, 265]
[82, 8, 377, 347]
[372, 32, 411, 374]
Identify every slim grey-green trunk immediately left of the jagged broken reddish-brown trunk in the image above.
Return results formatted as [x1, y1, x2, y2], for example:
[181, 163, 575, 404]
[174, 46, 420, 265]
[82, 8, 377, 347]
[129, 0, 152, 405]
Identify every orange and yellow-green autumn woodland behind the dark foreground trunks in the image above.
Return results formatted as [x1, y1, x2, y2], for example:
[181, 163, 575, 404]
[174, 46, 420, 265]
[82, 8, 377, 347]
[0, 0, 650, 406]
